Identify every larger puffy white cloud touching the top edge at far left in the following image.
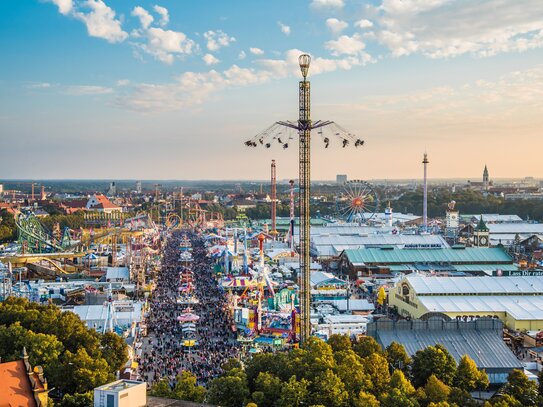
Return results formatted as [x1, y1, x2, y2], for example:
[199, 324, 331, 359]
[73, 0, 128, 43]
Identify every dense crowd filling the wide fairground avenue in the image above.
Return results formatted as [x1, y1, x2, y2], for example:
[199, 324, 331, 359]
[140, 231, 240, 386]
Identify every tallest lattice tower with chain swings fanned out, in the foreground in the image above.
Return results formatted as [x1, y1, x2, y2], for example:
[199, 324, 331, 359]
[245, 54, 364, 343]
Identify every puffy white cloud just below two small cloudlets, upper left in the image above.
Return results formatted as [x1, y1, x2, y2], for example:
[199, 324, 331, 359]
[137, 27, 197, 64]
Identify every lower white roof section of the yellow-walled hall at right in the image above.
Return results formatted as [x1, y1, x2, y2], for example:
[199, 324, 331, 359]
[418, 294, 543, 321]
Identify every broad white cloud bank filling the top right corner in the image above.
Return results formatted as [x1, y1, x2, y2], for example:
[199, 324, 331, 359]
[373, 0, 543, 58]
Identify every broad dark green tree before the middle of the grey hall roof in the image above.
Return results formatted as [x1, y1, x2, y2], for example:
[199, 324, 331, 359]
[411, 344, 456, 387]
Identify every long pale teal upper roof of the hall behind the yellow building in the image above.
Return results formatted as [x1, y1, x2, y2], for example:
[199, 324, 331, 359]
[345, 247, 513, 265]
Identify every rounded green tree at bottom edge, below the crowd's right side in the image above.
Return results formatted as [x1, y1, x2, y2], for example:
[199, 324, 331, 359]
[207, 369, 250, 407]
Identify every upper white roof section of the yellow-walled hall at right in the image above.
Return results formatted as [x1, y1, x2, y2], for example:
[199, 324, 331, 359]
[404, 274, 543, 300]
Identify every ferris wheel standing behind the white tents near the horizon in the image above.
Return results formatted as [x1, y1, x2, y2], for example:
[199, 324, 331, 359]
[337, 180, 379, 223]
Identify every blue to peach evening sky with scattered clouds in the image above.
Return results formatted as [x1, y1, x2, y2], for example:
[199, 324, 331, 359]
[0, 0, 543, 180]
